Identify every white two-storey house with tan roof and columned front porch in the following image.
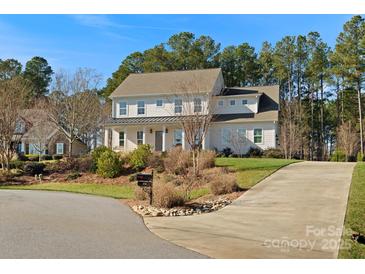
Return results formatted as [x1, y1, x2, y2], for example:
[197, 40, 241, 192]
[104, 68, 279, 154]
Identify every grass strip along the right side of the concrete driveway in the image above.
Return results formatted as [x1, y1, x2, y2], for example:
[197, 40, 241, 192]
[338, 162, 365, 259]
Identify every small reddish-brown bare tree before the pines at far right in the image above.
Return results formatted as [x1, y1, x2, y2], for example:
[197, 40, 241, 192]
[337, 121, 359, 159]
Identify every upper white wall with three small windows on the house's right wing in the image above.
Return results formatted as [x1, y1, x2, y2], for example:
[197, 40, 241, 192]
[214, 96, 259, 114]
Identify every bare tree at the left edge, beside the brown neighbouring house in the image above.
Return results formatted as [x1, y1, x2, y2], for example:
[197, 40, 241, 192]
[0, 77, 31, 170]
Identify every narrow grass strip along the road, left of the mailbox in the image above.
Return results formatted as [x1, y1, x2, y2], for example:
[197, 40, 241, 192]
[0, 183, 134, 199]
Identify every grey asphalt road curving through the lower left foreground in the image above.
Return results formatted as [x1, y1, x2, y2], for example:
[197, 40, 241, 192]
[0, 190, 206, 258]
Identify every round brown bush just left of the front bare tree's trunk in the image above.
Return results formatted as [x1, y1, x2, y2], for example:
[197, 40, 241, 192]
[164, 147, 192, 175]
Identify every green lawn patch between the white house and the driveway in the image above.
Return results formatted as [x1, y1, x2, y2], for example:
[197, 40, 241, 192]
[216, 158, 298, 189]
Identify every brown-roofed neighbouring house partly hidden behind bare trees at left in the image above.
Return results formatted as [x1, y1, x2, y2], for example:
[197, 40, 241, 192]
[16, 109, 87, 156]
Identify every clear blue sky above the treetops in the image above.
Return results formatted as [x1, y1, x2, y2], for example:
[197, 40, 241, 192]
[0, 15, 351, 85]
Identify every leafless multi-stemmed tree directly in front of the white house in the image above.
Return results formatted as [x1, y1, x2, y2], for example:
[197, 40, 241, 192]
[168, 77, 215, 176]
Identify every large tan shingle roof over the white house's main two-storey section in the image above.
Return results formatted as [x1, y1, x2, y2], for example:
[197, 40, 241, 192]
[110, 68, 222, 98]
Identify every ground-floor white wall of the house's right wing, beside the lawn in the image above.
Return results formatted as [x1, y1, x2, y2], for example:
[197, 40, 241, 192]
[209, 122, 277, 153]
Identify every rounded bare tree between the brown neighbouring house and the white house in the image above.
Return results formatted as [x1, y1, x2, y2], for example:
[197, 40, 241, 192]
[48, 68, 103, 157]
